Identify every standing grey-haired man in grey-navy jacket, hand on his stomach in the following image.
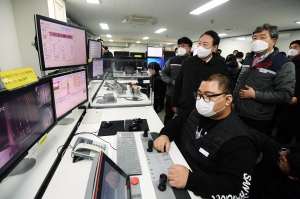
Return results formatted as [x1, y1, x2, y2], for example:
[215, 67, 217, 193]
[233, 24, 295, 133]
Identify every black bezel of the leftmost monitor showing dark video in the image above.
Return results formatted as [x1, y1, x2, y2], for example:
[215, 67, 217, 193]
[0, 77, 57, 182]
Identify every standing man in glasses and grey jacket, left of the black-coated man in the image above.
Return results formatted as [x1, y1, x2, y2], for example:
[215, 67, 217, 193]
[161, 37, 193, 125]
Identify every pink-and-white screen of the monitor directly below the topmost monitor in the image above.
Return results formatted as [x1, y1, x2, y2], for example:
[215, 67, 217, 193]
[52, 69, 88, 120]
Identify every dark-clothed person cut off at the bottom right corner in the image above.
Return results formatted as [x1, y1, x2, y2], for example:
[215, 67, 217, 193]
[249, 133, 300, 199]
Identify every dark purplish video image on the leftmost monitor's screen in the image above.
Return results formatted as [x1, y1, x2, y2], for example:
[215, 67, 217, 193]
[0, 82, 54, 168]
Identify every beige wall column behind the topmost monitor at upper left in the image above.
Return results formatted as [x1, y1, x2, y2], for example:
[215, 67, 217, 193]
[11, 0, 49, 76]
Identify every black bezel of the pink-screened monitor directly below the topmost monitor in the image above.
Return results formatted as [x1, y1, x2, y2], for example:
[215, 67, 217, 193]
[51, 68, 89, 122]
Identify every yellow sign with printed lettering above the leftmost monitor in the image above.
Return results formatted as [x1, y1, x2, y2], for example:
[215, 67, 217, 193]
[0, 68, 38, 90]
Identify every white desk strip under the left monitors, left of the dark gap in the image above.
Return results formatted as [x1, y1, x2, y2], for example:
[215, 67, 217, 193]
[0, 109, 84, 199]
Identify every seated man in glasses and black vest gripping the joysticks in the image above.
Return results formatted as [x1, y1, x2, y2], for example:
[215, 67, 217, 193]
[153, 74, 259, 198]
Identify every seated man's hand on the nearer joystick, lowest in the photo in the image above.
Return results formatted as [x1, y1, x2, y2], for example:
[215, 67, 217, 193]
[168, 164, 189, 189]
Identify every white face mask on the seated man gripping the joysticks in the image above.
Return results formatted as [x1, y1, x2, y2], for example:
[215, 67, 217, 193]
[196, 96, 226, 117]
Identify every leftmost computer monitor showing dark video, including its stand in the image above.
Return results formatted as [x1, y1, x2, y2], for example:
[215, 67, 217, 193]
[0, 78, 56, 182]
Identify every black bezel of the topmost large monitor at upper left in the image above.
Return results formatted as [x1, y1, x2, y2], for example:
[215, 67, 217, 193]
[34, 14, 88, 71]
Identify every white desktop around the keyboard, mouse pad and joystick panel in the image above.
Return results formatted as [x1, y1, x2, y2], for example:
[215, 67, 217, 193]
[43, 107, 200, 199]
